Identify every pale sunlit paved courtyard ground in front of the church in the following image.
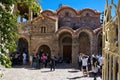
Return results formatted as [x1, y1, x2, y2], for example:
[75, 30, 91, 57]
[0, 64, 101, 80]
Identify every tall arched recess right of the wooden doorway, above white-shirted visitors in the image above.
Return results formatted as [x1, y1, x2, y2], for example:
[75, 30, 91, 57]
[79, 32, 91, 55]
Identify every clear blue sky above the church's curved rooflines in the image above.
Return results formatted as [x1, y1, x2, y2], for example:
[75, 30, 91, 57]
[40, 0, 106, 12]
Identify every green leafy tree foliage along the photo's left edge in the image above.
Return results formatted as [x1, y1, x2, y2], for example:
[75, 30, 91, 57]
[0, 0, 40, 67]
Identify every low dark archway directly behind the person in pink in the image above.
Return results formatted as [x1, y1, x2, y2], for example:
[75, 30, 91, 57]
[37, 45, 51, 58]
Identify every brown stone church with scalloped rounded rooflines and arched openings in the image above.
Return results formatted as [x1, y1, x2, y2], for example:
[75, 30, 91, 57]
[17, 5, 102, 63]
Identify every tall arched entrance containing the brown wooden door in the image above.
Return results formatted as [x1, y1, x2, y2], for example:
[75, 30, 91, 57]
[59, 32, 72, 63]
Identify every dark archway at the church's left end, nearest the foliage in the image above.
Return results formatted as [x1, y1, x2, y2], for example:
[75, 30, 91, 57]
[17, 38, 28, 53]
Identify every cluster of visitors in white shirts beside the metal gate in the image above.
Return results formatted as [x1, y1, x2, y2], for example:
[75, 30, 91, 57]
[78, 53, 102, 80]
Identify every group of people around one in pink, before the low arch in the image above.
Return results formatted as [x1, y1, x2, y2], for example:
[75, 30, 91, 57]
[31, 53, 57, 71]
